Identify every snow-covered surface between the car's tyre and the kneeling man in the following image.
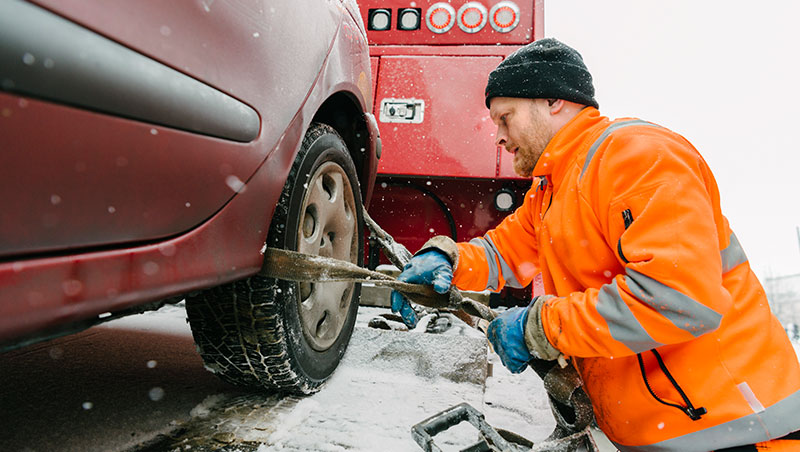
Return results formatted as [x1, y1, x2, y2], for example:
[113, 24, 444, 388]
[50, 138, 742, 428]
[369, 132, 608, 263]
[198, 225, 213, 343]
[251, 308, 554, 451]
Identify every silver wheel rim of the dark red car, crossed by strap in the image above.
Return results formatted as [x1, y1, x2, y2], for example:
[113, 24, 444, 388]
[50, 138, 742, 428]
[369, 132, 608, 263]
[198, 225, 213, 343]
[297, 162, 358, 351]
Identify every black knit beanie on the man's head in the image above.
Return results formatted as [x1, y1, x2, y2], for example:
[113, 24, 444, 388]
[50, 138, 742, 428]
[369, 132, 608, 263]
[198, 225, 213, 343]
[486, 38, 598, 108]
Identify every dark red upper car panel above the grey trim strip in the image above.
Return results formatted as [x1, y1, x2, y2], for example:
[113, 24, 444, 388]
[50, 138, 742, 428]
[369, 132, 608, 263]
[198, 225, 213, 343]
[28, 0, 343, 144]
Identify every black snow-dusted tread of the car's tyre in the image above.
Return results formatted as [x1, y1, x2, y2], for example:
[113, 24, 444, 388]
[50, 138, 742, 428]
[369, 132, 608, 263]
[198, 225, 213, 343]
[186, 124, 359, 394]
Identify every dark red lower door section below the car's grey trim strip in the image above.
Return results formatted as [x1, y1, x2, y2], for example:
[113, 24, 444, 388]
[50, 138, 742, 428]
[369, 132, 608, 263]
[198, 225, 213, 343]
[0, 93, 256, 256]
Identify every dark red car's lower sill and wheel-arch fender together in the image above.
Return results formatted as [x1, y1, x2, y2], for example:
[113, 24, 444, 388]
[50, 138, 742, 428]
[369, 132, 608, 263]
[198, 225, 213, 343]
[0, 4, 377, 350]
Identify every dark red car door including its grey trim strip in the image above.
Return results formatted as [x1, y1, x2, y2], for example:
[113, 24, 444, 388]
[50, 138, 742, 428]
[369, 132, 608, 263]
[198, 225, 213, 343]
[0, 0, 343, 257]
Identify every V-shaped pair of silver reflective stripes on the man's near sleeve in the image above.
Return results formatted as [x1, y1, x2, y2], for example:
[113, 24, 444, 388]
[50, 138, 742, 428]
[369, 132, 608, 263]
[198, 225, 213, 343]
[597, 268, 722, 353]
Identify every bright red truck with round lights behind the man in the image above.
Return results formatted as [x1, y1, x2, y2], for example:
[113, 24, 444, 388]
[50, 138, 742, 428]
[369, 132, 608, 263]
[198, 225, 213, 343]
[359, 0, 544, 304]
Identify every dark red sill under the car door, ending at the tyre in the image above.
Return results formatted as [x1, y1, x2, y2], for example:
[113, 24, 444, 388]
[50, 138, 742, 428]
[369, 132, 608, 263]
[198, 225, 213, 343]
[0, 108, 302, 342]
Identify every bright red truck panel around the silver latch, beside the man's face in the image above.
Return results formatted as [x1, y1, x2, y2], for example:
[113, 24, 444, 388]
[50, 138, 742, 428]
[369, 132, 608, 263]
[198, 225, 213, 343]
[375, 56, 501, 177]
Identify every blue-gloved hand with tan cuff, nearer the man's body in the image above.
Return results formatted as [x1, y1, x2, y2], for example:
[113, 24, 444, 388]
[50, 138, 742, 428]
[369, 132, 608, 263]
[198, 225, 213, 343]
[486, 296, 560, 374]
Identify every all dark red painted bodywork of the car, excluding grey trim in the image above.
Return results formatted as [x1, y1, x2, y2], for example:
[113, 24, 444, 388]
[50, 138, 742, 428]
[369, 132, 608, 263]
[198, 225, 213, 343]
[0, 0, 377, 343]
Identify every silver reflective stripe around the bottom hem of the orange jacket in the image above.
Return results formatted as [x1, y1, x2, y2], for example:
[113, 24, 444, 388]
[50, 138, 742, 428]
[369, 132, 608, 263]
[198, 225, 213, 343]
[616, 391, 800, 452]
